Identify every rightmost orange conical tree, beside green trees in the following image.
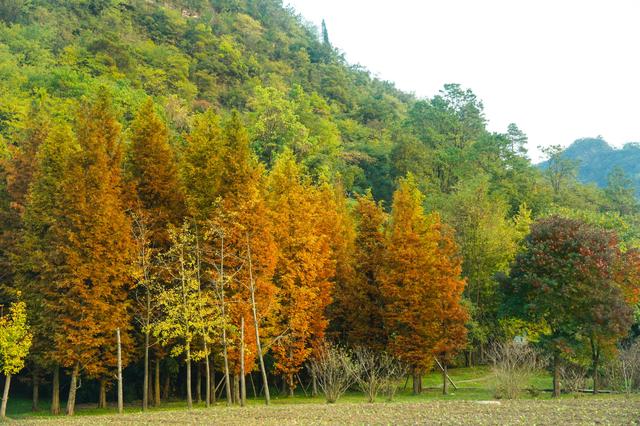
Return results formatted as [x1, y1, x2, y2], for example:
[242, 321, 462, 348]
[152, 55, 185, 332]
[381, 175, 467, 393]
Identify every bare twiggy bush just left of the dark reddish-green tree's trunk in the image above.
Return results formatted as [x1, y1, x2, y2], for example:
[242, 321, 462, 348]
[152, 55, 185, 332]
[489, 341, 544, 399]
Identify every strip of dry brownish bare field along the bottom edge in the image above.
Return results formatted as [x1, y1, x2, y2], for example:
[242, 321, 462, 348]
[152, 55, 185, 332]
[17, 397, 640, 425]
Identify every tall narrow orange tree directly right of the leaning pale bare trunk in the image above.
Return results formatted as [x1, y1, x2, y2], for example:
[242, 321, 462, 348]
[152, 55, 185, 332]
[267, 150, 335, 394]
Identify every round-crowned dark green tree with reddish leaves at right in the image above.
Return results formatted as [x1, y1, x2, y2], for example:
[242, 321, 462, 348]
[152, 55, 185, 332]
[503, 216, 637, 396]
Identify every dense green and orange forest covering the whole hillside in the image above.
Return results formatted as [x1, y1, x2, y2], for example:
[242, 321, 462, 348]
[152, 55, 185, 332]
[0, 0, 640, 414]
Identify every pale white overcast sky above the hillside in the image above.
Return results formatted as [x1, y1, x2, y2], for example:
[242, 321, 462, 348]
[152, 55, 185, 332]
[284, 0, 640, 160]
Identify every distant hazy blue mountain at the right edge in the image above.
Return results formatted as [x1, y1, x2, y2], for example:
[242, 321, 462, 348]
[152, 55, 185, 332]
[540, 138, 640, 195]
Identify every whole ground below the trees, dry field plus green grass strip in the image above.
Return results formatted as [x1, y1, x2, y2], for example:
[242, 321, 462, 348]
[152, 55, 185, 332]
[8, 368, 640, 425]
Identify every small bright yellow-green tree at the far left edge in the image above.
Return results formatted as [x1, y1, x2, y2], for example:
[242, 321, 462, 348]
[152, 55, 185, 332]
[0, 301, 32, 419]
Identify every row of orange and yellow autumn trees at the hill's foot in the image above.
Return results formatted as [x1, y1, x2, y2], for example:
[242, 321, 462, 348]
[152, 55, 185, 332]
[7, 93, 467, 414]
